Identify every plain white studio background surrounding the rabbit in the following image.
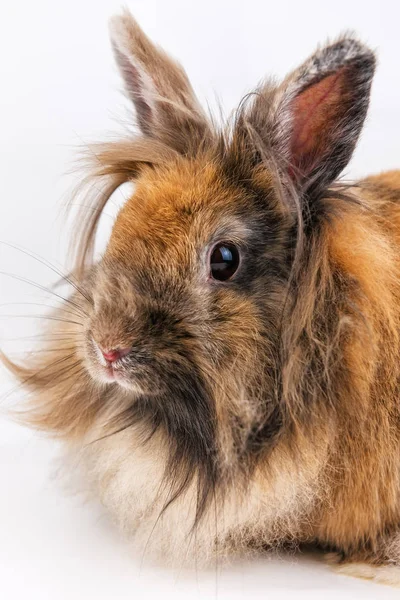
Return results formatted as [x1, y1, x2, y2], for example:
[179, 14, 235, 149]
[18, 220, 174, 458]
[0, 0, 400, 600]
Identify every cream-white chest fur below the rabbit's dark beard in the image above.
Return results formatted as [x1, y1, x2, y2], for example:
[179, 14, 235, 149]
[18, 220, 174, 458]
[61, 428, 322, 568]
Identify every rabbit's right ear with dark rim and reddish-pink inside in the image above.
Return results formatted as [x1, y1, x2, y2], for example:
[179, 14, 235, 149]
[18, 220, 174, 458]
[247, 37, 375, 193]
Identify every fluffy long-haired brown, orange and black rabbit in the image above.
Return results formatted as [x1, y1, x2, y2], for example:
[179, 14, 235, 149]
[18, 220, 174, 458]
[4, 8, 400, 584]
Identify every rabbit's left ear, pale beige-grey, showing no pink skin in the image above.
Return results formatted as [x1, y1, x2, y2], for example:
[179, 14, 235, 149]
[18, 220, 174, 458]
[110, 11, 210, 153]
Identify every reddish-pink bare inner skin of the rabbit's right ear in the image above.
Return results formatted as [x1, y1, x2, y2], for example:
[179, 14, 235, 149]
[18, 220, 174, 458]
[291, 67, 345, 178]
